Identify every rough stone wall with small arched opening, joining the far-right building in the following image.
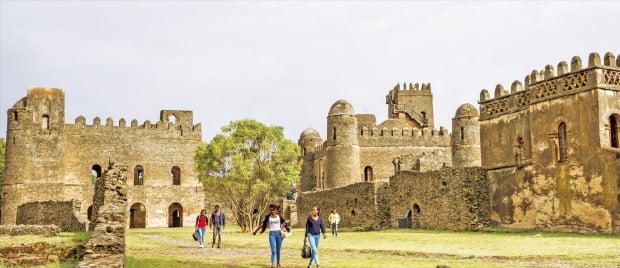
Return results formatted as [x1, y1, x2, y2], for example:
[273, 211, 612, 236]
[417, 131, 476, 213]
[387, 168, 490, 230]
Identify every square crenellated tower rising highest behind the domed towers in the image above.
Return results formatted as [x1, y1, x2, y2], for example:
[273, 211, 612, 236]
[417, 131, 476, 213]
[385, 83, 435, 129]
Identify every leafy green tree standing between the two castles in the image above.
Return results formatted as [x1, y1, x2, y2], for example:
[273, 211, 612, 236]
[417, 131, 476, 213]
[195, 119, 301, 232]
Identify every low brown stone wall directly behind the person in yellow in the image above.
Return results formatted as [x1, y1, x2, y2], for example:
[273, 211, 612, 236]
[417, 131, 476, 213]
[297, 182, 385, 228]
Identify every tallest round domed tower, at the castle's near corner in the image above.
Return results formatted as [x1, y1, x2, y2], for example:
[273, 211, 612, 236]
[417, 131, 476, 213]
[324, 100, 361, 189]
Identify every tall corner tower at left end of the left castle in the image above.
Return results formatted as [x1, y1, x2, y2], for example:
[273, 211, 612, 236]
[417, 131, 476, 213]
[1, 87, 65, 224]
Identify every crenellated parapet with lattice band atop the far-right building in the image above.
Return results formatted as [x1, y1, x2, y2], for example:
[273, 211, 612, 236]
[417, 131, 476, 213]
[479, 52, 620, 120]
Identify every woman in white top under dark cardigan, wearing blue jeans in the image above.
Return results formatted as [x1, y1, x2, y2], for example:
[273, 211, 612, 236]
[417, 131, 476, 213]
[253, 204, 286, 268]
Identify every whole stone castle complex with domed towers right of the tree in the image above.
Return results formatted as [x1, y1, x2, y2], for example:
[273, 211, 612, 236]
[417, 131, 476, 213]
[297, 53, 620, 233]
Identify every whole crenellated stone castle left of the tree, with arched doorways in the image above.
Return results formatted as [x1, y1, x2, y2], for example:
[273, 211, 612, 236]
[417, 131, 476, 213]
[1, 88, 204, 227]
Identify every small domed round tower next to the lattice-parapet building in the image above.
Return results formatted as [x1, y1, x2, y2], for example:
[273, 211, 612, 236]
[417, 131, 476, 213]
[451, 103, 481, 167]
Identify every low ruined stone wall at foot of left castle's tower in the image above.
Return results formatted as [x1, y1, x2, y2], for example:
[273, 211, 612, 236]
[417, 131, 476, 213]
[17, 200, 88, 232]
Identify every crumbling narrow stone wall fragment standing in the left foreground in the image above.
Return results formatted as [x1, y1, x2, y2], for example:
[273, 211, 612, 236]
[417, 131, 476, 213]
[78, 164, 127, 267]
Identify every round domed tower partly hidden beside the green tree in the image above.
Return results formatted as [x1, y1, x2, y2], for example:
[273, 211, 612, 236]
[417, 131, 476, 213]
[297, 128, 323, 192]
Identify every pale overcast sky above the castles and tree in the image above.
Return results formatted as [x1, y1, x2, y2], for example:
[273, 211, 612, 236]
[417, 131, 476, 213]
[0, 0, 620, 141]
